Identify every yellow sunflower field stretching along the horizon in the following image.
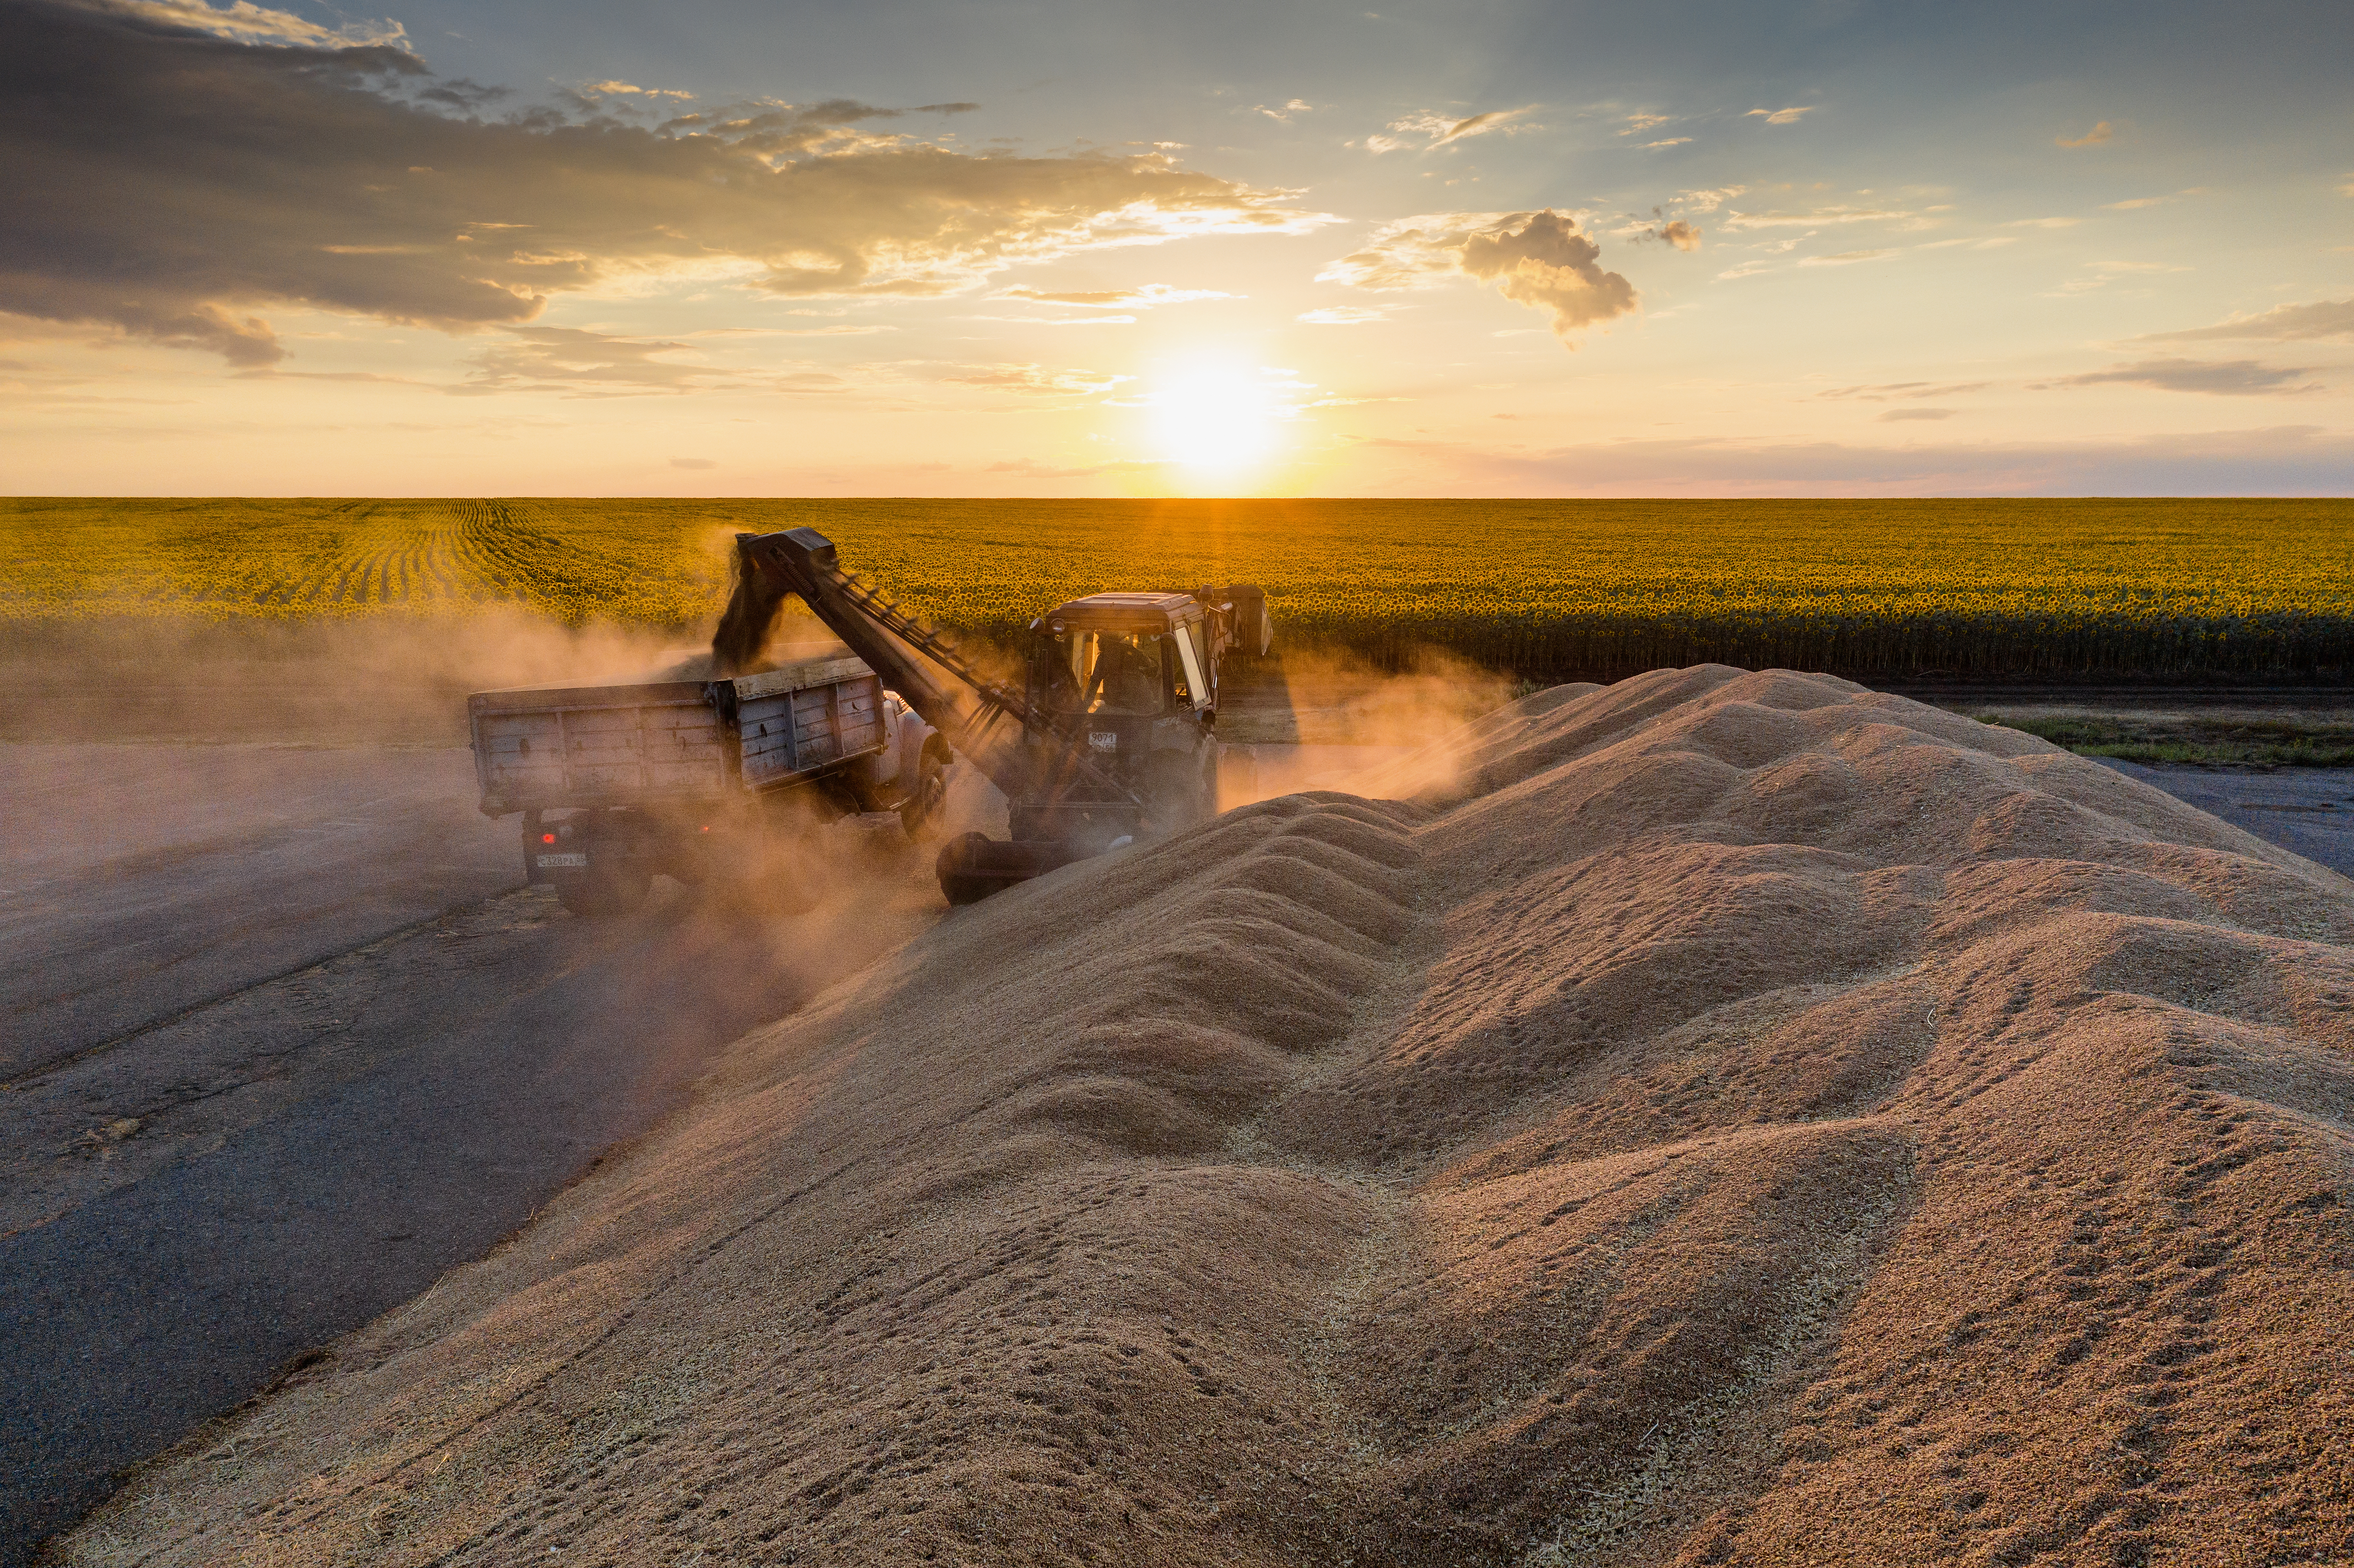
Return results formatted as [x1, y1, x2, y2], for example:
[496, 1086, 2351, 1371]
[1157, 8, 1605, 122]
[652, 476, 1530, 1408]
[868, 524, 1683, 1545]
[0, 499, 2354, 678]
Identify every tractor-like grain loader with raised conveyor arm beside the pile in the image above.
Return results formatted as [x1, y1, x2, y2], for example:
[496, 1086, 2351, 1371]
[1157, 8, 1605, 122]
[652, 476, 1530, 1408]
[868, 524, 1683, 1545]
[713, 527, 1274, 904]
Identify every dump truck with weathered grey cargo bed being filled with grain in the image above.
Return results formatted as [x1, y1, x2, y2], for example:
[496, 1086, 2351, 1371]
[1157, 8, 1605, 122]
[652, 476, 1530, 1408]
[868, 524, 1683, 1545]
[466, 657, 949, 916]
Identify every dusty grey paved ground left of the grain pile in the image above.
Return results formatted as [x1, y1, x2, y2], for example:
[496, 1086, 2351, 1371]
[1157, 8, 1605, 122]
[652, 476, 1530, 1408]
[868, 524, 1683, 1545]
[0, 747, 939, 1563]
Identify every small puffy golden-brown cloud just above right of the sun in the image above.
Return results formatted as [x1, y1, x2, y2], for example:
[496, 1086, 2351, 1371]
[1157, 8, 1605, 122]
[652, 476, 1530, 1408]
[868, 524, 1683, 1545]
[1316, 207, 1636, 344]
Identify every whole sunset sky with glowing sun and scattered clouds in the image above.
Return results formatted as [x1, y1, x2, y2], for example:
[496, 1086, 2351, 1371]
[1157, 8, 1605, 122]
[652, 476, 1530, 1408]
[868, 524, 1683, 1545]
[0, 0, 2354, 497]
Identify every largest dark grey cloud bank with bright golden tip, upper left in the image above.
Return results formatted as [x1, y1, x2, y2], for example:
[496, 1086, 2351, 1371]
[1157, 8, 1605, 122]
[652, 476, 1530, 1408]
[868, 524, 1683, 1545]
[0, 0, 1325, 365]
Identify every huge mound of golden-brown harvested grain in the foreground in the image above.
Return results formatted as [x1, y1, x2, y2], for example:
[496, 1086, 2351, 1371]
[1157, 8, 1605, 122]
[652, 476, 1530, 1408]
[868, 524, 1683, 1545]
[66, 666, 2354, 1566]
